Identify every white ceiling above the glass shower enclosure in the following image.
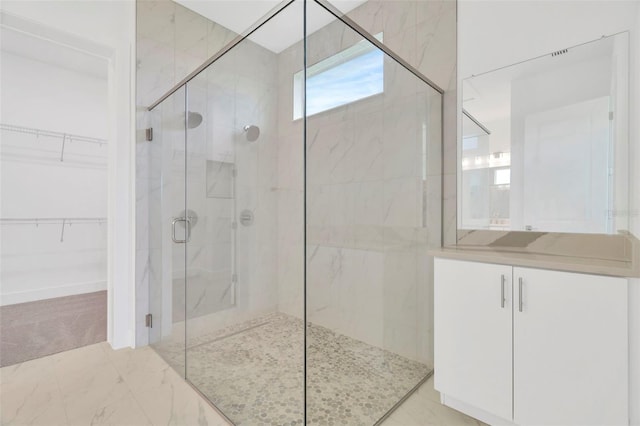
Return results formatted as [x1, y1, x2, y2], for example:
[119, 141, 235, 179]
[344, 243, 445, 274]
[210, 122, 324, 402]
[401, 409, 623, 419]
[175, 0, 366, 53]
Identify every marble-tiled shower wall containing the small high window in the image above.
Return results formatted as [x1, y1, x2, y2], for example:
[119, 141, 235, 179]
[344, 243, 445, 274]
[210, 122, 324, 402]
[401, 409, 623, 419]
[278, 1, 455, 362]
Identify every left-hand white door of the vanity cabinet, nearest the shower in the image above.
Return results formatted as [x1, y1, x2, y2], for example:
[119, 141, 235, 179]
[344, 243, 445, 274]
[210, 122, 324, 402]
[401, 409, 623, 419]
[434, 259, 512, 419]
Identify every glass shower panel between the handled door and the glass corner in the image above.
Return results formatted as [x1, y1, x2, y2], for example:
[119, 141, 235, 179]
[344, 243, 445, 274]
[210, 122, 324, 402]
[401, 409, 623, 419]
[180, 2, 304, 425]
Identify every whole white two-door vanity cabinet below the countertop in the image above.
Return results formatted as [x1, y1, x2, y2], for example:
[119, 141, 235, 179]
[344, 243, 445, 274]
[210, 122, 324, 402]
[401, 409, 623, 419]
[435, 258, 629, 425]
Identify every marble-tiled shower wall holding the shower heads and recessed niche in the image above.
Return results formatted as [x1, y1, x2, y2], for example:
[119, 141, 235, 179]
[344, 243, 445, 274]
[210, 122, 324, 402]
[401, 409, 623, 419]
[167, 50, 277, 335]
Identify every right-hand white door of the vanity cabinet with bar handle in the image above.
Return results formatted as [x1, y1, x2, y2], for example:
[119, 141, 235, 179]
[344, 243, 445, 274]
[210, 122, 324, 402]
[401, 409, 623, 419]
[512, 267, 629, 425]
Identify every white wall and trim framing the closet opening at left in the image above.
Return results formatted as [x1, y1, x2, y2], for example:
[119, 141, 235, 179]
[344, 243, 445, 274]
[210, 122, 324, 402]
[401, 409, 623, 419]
[0, 0, 135, 348]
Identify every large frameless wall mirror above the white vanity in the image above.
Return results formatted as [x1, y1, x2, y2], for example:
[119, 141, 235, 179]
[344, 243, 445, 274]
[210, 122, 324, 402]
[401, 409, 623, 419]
[458, 32, 629, 234]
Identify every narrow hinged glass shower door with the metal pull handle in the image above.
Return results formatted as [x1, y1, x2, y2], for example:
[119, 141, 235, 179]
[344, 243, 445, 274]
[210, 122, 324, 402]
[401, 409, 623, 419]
[148, 87, 191, 375]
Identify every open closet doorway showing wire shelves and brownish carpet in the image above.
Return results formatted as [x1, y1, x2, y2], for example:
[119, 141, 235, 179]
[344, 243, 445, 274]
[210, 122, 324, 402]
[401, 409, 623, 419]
[0, 13, 109, 366]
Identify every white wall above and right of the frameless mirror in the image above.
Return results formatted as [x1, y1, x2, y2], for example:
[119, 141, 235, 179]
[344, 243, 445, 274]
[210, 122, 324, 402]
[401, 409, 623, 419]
[458, 0, 640, 425]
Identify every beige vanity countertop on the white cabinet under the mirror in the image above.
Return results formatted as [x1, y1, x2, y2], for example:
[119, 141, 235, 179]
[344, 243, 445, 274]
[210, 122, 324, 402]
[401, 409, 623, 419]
[429, 246, 640, 278]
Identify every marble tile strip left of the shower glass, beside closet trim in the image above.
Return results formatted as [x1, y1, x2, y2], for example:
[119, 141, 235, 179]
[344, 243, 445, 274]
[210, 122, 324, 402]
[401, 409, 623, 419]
[135, 0, 241, 345]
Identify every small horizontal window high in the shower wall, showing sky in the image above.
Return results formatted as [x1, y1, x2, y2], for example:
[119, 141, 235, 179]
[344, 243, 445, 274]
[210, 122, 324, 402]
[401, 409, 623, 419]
[293, 33, 384, 120]
